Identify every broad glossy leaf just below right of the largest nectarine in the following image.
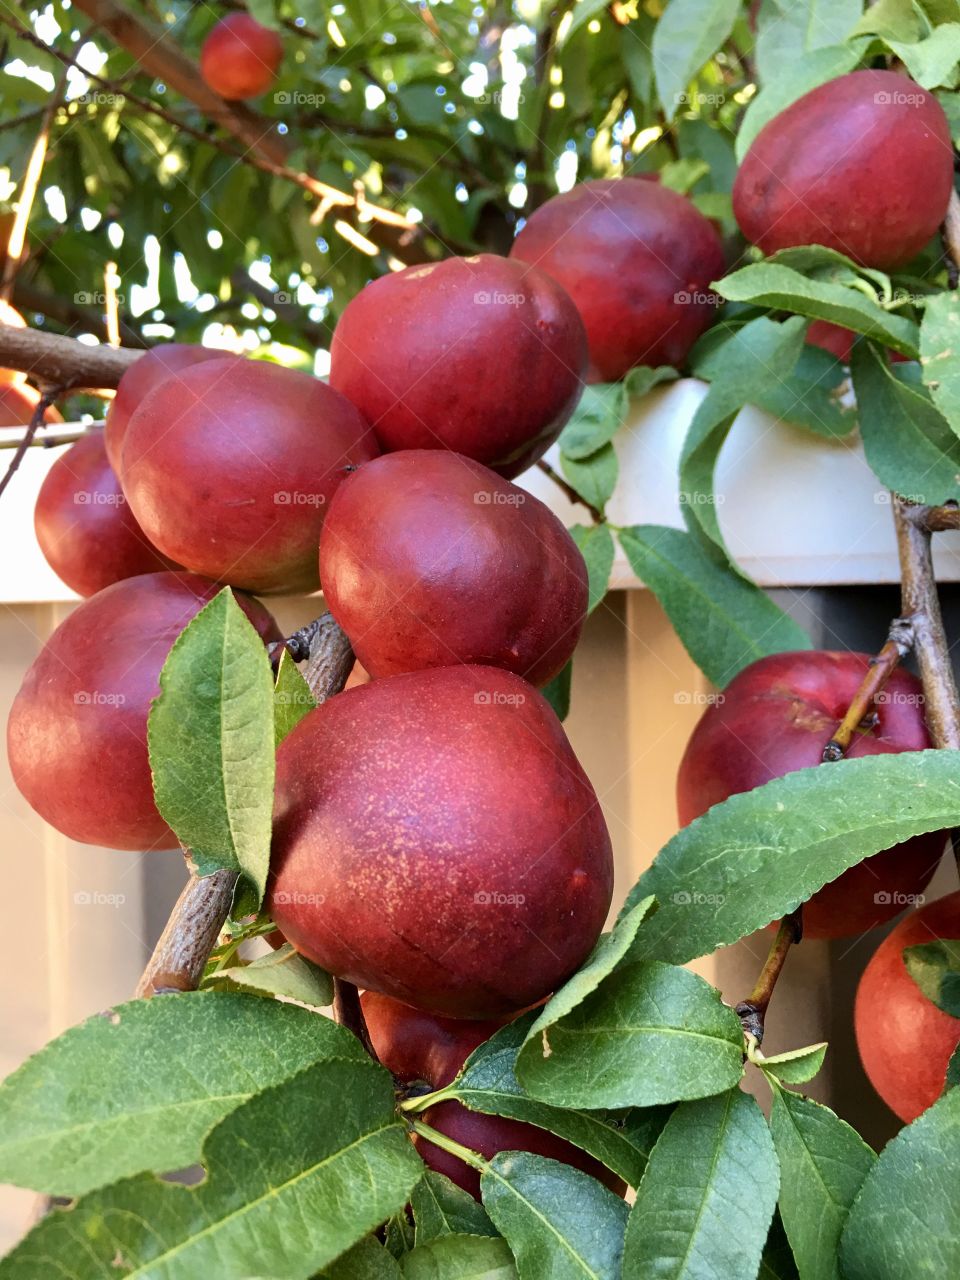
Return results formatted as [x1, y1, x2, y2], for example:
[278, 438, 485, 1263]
[517, 962, 744, 1107]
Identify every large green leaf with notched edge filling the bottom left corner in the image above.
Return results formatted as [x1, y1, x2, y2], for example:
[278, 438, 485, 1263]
[0, 1054, 422, 1280]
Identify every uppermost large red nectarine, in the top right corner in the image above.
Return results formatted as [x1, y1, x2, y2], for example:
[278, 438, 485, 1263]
[733, 70, 954, 270]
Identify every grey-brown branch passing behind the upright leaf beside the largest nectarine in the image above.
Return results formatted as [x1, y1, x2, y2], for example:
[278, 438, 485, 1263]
[136, 613, 353, 997]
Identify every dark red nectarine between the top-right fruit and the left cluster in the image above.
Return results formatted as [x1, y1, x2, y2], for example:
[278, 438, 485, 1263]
[511, 178, 723, 383]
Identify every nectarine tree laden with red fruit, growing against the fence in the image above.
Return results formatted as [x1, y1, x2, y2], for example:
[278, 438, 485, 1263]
[0, 0, 960, 1280]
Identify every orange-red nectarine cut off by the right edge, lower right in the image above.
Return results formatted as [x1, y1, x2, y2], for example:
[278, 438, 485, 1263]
[854, 893, 960, 1124]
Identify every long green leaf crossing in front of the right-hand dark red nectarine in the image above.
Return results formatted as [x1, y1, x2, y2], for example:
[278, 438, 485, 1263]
[623, 750, 960, 964]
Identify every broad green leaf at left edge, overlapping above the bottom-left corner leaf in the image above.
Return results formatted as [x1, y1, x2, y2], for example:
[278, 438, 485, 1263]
[0, 992, 364, 1196]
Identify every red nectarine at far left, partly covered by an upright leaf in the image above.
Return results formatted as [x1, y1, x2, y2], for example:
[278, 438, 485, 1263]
[6, 573, 280, 849]
